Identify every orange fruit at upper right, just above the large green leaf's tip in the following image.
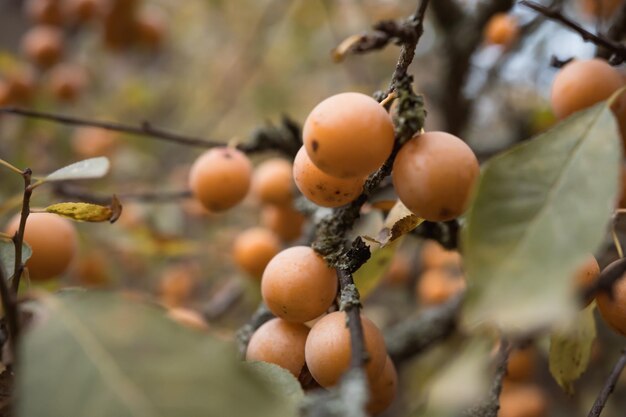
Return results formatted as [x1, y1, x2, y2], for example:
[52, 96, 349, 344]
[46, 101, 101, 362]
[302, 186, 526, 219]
[550, 58, 624, 119]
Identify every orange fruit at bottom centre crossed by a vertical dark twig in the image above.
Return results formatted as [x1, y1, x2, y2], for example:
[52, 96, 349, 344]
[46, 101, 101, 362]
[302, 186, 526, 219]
[304, 311, 387, 388]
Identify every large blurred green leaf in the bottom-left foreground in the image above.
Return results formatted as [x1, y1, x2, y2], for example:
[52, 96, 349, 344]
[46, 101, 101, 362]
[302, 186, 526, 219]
[16, 291, 294, 417]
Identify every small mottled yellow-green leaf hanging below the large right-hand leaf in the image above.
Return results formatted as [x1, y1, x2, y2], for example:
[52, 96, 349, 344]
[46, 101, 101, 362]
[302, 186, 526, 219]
[548, 303, 596, 394]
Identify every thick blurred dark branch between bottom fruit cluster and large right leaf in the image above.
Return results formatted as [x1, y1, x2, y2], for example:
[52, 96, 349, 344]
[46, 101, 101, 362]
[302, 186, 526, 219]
[385, 295, 463, 364]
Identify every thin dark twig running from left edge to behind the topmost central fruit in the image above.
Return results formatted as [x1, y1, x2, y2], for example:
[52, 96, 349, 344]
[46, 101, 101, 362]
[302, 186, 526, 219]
[0, 107, 302, 157]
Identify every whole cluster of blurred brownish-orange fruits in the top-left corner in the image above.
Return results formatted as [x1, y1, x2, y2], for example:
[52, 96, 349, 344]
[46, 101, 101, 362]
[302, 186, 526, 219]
[0, 0, 165, 105]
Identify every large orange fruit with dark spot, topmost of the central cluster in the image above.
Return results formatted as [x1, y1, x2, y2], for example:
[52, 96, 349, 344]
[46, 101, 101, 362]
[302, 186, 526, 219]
[302, 93, 394, 178]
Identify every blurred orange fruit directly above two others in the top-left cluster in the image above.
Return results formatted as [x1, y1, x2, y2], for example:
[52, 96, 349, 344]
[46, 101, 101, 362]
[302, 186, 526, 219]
[22, 26, 64, 69]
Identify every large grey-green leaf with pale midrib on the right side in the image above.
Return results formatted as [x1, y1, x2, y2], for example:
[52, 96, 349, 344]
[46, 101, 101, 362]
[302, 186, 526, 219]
[463, 103, 622, 332]
